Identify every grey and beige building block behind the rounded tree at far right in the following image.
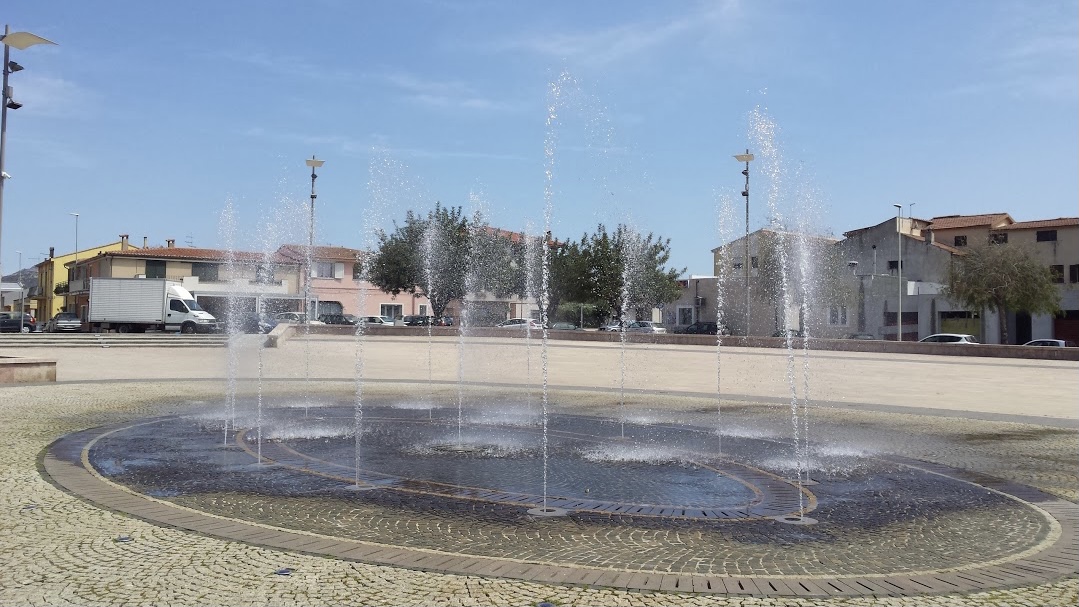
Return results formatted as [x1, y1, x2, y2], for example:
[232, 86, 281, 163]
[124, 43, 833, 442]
[838, 212, 1079, 344]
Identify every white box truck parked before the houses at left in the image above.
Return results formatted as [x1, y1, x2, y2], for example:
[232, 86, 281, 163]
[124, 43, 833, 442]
[88, 278, 217, 333]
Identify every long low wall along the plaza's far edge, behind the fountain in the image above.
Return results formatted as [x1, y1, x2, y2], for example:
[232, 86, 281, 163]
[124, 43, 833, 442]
[267, 325, 1079, 360]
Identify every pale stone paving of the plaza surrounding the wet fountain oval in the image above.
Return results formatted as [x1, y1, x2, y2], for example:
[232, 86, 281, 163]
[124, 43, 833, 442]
[0, 339, 1079, 605]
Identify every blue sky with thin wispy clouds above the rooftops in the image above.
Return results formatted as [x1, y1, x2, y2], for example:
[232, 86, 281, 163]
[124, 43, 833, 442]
[0, 0, 1079, 274]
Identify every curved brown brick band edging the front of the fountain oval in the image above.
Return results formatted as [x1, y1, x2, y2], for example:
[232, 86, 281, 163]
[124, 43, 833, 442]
[40, 416, 1079, 597]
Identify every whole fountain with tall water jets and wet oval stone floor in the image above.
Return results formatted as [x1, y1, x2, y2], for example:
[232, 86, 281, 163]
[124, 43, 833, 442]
[38, 92, 1062, 595]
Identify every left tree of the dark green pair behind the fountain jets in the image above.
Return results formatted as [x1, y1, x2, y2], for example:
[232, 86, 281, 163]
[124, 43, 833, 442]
[368, 204, 470, 317]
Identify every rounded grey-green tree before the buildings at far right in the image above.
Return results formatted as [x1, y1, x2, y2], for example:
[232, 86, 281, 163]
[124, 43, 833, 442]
[943, 244, 1061, 344]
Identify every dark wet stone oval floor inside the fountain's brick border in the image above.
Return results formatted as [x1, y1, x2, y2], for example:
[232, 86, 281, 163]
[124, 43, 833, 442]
[91, 405, 1050, 576]
